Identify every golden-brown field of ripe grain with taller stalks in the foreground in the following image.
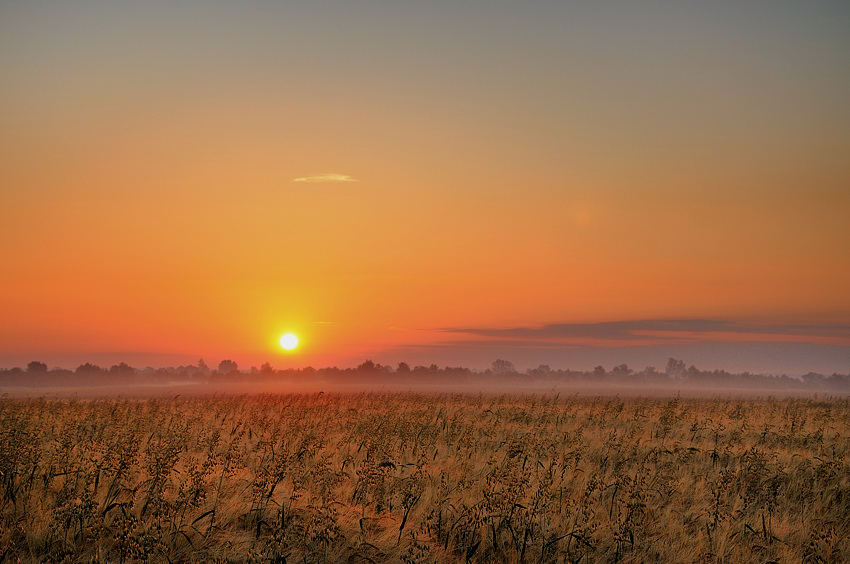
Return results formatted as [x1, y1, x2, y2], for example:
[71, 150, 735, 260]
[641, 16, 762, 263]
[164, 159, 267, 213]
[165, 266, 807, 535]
[0, 393, 850, 563]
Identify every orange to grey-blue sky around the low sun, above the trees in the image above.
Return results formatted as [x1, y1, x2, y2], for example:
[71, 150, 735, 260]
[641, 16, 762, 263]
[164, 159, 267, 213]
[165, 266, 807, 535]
[0, 0, 850, 373]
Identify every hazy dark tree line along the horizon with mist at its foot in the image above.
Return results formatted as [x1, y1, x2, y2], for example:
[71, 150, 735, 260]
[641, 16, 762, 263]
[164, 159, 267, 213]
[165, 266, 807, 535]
[0, 358, 850, 391]
